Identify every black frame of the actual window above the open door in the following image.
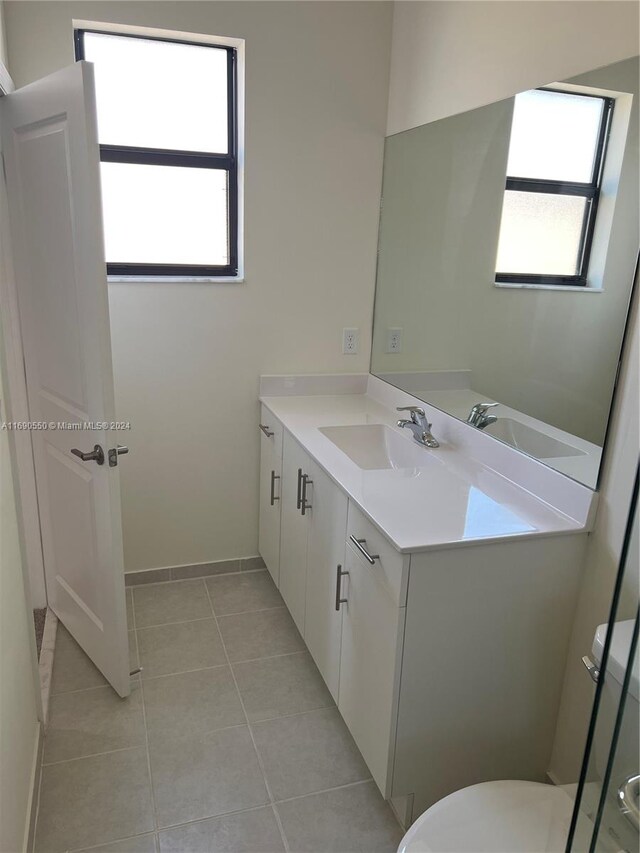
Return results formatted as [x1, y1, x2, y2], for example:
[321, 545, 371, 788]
[73, 26, 240, 280]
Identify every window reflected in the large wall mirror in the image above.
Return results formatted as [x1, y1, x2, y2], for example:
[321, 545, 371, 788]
[496, 89, 613, 287]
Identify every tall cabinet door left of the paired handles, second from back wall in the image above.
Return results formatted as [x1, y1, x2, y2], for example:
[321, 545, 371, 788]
[279, 433, 312, 636]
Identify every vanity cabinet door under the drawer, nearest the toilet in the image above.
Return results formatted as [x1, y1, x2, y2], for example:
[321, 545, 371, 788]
[338, 545, 405, 797]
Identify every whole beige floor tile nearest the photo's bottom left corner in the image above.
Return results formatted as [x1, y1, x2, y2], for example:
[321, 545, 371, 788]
[35, 749, 154, 853]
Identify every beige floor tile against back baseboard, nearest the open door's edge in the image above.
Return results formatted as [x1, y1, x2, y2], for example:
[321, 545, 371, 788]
[133, 580, 212, 628]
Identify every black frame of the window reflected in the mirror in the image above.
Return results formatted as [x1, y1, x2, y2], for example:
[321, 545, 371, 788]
[495, 86, 615, 287]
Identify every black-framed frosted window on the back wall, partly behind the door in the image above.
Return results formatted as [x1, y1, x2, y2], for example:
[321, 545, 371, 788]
[75, 29, 238, 277]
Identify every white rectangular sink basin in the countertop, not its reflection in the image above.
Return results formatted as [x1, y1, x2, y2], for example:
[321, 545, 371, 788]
[320, 424, 428, 471]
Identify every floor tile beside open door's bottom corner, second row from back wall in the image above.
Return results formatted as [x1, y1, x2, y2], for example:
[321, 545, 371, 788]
[137, 618, 226, 678]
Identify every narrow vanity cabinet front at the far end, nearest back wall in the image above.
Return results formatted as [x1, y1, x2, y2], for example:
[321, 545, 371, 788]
[258, 406, 282, 586]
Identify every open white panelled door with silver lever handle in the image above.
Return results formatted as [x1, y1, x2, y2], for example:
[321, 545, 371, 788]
[0, 62, 130, 696]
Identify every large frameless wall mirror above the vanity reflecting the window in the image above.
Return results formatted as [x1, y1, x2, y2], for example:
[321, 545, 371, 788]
[371, 57, 639, 488]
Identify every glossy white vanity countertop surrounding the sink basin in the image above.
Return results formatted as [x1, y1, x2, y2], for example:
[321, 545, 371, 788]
[260, 394, 587, 553]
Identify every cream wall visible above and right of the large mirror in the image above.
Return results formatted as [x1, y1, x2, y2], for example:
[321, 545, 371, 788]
[388, 0, 639, 781]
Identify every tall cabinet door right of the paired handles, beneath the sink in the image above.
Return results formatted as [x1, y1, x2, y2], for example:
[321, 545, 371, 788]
[304, 463, 348, 702]
